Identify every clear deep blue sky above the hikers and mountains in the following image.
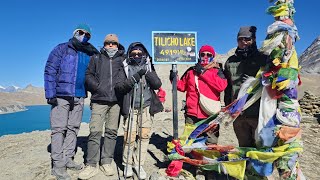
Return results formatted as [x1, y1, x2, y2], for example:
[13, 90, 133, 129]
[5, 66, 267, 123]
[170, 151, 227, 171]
[0, 0, 320, 87]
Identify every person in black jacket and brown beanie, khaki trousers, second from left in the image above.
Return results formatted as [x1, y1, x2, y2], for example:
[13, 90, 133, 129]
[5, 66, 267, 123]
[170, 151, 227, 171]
[79, 34, 125, 179]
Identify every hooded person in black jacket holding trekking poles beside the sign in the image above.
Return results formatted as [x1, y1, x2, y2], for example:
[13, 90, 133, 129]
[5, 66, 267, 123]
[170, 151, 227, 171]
[115, 42, 163, 179]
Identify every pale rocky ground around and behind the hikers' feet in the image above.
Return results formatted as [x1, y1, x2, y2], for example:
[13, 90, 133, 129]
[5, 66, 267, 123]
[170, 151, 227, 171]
[0, 109, 320, 180]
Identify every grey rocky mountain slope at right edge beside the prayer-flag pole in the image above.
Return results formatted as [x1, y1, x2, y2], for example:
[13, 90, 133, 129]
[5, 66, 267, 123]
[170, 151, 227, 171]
[299, 36, 320, 74]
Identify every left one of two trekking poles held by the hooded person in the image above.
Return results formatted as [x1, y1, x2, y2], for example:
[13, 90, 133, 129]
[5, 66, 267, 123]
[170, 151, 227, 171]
[124, 83, 138, 180]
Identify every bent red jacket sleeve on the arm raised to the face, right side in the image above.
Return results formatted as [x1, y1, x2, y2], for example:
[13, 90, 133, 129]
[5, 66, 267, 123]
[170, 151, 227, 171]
[199, 69, 228, 92]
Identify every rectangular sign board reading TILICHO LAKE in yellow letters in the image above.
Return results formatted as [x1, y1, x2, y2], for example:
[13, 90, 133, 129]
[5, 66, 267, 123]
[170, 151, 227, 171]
[152, 31, 197, 64]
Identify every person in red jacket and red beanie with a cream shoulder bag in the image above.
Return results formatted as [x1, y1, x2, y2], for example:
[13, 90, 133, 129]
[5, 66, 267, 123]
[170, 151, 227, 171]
[170, 45, 227, 144]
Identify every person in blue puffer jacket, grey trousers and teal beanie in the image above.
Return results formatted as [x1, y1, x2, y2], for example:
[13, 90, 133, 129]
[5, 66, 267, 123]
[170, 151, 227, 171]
[44, 24, 99, 179]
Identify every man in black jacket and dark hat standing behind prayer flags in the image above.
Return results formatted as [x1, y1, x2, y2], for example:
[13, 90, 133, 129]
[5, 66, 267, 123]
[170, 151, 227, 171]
[224, 26, 267, 147]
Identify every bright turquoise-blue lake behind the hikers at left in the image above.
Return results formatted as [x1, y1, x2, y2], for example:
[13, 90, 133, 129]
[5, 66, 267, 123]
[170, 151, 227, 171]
[0, 105, 90, 136]
